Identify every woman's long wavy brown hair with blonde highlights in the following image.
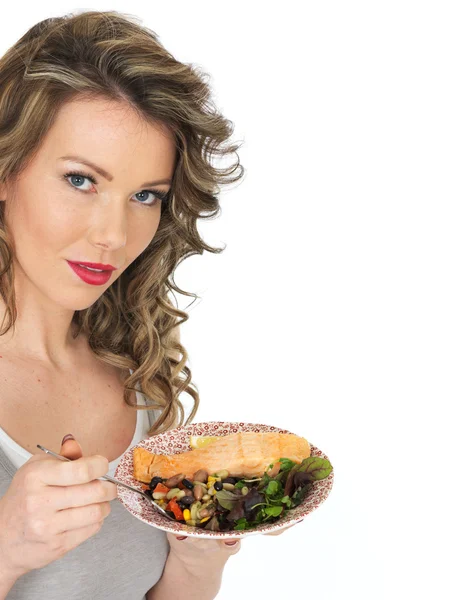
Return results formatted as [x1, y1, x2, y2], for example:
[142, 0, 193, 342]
[0, 11, 244, 435]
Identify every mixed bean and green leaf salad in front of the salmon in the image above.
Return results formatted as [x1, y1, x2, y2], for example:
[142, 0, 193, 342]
[144, 456, 333, 531]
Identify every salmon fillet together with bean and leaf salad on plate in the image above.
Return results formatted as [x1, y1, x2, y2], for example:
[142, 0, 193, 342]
[133, 433, 333, 531]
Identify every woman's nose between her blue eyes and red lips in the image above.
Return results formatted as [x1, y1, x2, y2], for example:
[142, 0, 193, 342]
[89, 200, 127, 250]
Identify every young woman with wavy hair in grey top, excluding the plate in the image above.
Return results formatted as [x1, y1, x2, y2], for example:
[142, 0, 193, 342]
[0, 12, 292, 600]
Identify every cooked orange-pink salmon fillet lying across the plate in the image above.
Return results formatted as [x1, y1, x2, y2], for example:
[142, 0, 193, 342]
[133, 432, 311, 483]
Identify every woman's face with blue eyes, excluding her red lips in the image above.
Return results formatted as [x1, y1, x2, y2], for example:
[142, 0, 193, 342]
[1, 99, 176, 310]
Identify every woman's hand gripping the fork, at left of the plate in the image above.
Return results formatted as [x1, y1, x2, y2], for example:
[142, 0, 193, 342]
[0, 439, 117, 580]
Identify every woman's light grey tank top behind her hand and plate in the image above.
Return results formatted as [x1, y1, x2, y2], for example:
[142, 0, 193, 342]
[0, 396, 169, 600]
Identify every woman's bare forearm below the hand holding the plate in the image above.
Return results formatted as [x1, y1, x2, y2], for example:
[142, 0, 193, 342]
[146, 552, 224, 600]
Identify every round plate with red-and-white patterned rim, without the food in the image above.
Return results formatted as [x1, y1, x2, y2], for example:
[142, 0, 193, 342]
[114, 421, 334, 539]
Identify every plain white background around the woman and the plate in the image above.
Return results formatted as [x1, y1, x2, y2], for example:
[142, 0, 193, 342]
[0, 0, 450, 600]
